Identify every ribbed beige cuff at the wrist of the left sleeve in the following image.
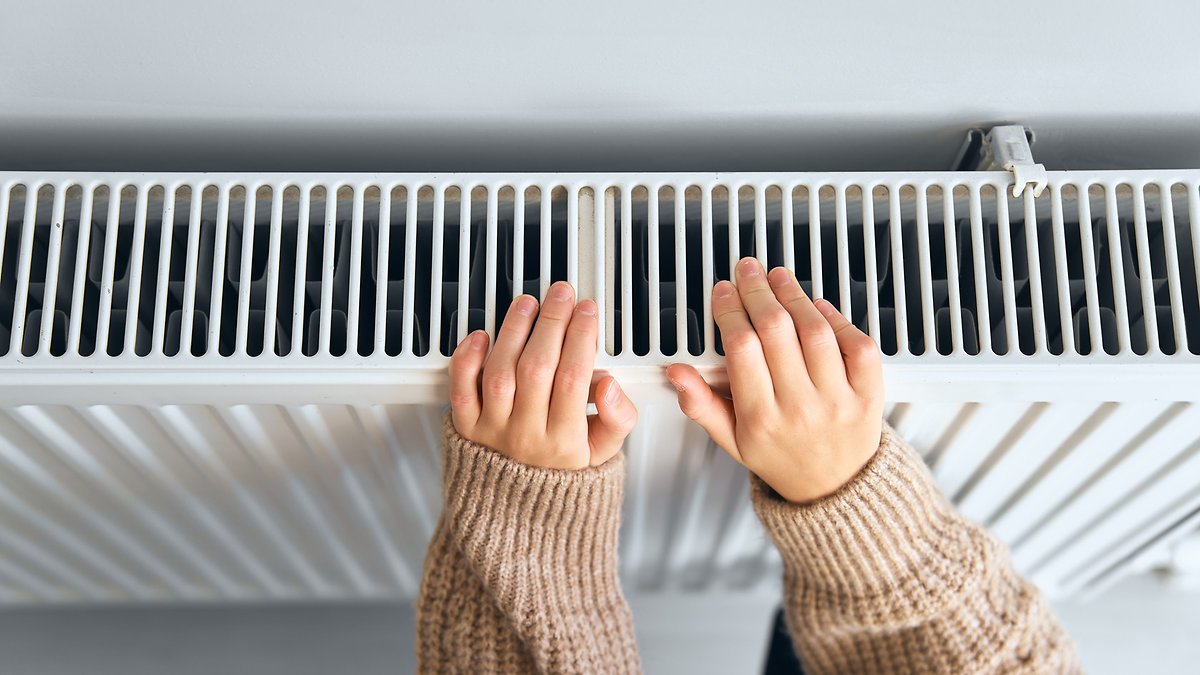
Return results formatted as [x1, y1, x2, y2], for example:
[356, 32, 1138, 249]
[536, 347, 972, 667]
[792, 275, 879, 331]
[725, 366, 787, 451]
[443, 416, 625, 604]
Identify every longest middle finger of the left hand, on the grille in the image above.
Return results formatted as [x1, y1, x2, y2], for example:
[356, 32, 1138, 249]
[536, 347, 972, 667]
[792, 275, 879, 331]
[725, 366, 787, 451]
[512, 281, 575, 420]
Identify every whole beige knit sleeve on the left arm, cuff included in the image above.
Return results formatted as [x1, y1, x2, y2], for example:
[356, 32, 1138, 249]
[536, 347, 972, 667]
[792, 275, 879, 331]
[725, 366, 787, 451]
[416, 416, 640, 674]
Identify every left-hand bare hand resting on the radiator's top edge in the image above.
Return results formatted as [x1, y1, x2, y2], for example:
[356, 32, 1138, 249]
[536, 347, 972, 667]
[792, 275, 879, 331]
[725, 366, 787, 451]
[450, 281, 637, 468]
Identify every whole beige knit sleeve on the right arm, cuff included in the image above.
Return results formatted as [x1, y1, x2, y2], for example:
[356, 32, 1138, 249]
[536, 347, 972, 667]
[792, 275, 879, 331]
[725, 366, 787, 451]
[751, 429, 1079, 674]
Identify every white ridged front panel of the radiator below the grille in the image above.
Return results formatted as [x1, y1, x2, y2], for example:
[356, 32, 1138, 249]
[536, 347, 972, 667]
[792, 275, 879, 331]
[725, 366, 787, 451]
[0, 402, 1200, 603]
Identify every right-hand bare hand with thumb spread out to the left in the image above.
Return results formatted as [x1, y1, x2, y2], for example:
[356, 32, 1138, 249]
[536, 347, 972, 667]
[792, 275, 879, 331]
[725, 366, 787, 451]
[667, 258, 883, 503]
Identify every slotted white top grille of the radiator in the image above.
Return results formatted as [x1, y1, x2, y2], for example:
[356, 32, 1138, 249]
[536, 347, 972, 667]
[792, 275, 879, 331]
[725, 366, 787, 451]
[0, 172, 1200, 363]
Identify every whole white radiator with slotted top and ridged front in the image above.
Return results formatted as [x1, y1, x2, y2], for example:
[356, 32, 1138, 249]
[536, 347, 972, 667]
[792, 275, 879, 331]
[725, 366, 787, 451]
[0, 171, 1200, 603]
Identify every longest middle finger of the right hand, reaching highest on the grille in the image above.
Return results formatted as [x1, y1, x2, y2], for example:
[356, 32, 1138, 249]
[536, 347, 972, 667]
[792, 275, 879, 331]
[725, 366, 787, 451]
[737, 258, 804, 384]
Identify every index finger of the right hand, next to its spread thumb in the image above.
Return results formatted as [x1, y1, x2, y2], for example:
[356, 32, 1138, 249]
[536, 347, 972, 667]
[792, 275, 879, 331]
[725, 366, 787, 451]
[713, 281, 777, 410]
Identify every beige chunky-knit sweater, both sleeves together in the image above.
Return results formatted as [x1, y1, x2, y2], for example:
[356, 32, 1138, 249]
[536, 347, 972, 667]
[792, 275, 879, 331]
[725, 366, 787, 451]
[416, 417, 1079, 674]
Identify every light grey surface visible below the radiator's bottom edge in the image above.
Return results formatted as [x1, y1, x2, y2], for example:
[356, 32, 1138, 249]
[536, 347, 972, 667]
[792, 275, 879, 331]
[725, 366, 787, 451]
[0, 577, 1200, 675]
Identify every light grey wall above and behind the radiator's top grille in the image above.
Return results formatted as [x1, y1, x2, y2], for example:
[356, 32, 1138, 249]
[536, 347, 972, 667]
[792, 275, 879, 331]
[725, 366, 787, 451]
[0, 0, 1200, 171]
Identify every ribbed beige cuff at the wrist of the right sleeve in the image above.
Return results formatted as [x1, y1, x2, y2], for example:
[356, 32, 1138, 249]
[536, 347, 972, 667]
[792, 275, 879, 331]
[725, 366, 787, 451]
[751, 428, 992, 614]
